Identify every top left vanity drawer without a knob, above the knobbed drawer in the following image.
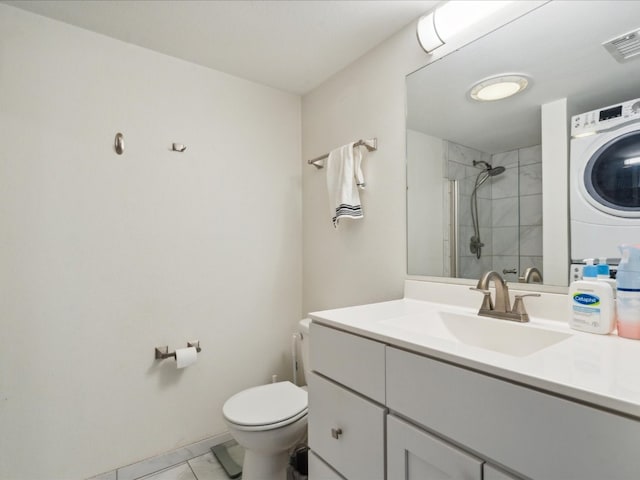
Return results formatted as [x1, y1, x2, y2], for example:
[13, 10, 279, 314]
[309, 321, 385, 403]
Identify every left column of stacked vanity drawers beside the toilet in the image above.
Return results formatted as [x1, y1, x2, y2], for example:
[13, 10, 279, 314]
[307, 323, 386, 480]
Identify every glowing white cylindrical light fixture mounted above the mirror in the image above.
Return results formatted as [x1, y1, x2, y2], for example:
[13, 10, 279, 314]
[417, 0, 513, 53]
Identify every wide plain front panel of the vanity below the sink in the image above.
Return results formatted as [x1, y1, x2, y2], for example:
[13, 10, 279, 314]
[387, 347, 640, 480]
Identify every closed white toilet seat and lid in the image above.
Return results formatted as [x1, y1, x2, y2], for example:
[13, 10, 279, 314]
[222, 382, 308, 431]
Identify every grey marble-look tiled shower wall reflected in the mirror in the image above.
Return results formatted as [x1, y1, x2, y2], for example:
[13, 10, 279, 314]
[443, 140, 542, 281]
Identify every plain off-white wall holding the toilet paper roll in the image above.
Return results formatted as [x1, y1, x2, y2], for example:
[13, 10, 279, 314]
[0, 4, 302, 480]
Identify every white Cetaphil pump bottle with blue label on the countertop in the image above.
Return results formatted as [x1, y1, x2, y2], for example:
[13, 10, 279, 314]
[569, 259, 615, 335]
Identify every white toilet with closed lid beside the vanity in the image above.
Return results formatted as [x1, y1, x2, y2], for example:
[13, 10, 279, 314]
[222, 318, 311, 480]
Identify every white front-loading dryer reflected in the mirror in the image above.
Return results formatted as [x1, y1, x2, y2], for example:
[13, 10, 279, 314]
[569, 99, 640, 281]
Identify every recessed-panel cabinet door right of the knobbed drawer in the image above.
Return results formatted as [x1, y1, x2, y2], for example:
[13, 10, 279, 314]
[387, 415, 483, 480]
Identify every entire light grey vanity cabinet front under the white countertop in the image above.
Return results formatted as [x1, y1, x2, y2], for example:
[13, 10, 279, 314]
[309, 321, 640, 480]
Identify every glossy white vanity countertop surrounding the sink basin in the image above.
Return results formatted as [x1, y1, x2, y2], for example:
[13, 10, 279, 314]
[310, 282, 640, 419]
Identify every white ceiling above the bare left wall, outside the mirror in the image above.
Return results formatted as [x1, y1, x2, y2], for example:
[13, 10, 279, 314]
[2, 0, 439, 94]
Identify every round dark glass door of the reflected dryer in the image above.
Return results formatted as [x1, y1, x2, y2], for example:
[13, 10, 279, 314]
[584, 131, 640, 216]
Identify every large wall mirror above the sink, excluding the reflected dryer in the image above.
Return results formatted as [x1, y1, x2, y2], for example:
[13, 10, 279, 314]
[406, 0, 640, 286]
